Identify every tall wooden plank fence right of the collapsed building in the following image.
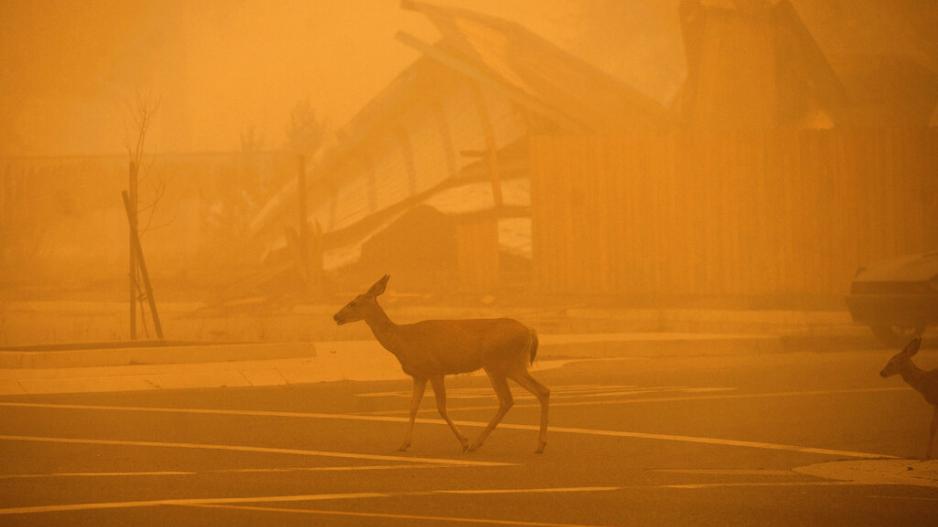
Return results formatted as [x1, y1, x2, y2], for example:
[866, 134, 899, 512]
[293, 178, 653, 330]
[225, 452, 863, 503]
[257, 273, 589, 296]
[530, 129, 938, 297]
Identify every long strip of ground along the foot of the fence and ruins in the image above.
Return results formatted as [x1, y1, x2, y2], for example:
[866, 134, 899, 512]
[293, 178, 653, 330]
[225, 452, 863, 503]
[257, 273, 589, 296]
[0, 299, 875, 347]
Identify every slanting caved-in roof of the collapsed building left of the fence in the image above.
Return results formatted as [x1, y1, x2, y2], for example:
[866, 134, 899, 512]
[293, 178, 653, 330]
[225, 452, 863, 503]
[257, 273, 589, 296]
[250, 2, 667, 266]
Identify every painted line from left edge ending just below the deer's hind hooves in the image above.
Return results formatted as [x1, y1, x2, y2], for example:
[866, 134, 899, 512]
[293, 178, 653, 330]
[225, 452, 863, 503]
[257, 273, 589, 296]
[0, 435, 511, 467]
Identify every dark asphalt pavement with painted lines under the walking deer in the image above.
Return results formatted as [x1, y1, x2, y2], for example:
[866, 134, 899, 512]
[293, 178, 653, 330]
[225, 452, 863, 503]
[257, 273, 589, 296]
[0, 350, 938, 527]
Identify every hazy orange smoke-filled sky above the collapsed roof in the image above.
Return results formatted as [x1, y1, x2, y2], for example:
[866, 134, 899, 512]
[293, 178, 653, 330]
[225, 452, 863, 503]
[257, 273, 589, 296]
[0, 0, 682, 155]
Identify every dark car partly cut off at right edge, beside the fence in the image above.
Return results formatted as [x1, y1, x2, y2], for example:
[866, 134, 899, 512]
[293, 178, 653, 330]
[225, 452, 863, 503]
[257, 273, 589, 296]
[847, 251, 938, 347]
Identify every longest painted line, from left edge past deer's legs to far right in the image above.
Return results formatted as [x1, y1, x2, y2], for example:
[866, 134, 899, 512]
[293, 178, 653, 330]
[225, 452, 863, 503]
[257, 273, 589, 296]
[0, 402, 895, 460]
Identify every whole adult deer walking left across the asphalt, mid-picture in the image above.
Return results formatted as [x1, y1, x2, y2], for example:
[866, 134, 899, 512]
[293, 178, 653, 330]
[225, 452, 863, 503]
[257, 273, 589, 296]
[333, 274, 550, 454]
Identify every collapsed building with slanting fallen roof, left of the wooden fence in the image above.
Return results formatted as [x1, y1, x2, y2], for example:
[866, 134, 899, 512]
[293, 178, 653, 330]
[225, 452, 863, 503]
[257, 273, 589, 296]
[252, 2, 668, 291]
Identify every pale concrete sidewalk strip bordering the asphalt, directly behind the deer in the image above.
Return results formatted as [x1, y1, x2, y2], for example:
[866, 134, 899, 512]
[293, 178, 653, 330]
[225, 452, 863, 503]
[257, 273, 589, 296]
[0, 333, 782, 395]
